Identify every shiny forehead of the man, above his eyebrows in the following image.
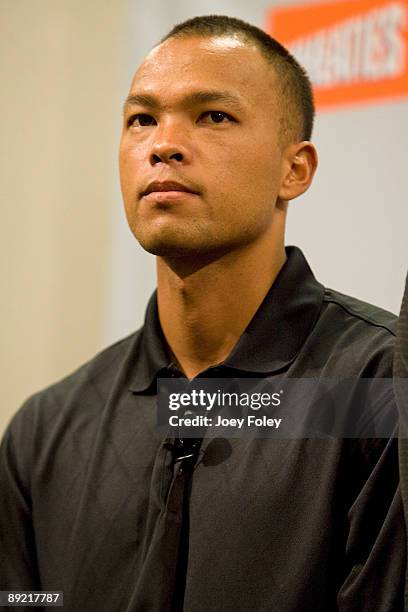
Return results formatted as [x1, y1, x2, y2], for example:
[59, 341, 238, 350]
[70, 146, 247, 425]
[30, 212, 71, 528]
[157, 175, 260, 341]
[131, 36, 276, 105]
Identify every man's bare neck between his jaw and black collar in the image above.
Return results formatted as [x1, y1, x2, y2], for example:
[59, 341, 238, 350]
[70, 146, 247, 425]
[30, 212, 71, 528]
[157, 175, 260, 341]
[157, 218, 286, 379]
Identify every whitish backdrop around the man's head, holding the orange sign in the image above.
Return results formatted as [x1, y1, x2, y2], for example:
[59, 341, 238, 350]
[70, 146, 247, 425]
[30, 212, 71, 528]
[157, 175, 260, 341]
[105, 0, 408, 343]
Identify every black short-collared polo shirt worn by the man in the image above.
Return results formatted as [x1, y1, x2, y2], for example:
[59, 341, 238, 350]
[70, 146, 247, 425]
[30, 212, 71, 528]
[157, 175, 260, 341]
[0, 247, 405, 612]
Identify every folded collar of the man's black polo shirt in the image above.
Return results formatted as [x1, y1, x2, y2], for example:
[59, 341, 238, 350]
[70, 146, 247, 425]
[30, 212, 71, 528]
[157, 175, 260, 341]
[130, 247, 324, 392]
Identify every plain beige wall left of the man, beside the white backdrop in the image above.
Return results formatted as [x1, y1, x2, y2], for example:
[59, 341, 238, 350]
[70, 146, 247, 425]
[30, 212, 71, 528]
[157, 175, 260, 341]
[0, 0, 128, 433]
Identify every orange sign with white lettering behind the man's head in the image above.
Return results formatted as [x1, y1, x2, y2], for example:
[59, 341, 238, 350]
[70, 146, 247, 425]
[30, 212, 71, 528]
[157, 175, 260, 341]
[266, 0, 408, 109]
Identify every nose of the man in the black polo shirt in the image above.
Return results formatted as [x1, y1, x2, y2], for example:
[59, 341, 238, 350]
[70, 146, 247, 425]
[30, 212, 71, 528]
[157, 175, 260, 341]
[149, 126, 191, 166]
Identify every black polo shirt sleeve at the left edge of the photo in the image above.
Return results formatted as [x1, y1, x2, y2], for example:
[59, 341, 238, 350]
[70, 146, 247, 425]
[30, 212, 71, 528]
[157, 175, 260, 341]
[0, 407, 41, 592]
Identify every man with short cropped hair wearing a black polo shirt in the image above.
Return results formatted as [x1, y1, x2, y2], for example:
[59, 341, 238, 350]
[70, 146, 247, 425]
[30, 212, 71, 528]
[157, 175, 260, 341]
[0, 16, 405, 612]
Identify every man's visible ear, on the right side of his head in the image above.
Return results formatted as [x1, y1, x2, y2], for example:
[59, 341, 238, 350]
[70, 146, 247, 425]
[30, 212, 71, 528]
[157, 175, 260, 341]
[278, 140, 318, 201]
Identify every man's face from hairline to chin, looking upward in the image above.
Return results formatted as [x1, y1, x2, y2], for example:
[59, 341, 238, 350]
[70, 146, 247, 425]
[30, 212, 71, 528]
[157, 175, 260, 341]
[120, 36, 283, 256]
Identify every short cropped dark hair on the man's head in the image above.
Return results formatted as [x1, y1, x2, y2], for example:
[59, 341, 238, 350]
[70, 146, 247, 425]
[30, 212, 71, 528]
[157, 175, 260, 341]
[160, 15, 315, 146]
